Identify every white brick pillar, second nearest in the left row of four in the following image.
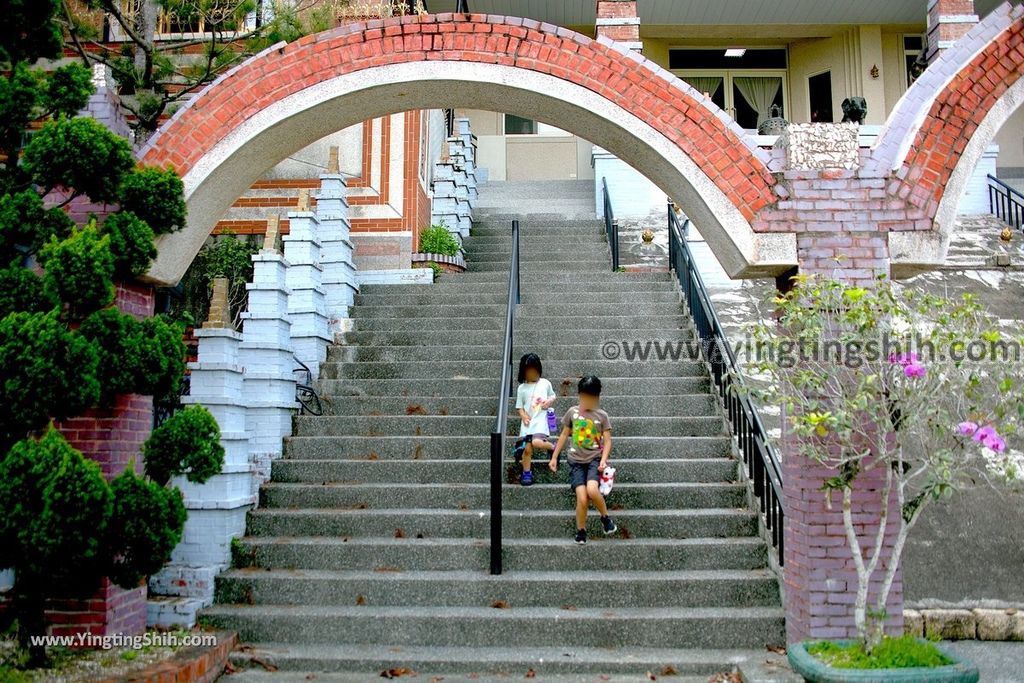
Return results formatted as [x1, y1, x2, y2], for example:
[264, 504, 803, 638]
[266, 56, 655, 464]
[240, 216, 298, 488]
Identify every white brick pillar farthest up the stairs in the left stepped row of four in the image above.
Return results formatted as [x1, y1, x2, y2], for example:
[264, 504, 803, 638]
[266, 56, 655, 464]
[316, 147, 358, 334]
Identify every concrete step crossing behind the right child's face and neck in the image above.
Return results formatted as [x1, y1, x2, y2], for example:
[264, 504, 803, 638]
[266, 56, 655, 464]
[322, 395, 721, 420]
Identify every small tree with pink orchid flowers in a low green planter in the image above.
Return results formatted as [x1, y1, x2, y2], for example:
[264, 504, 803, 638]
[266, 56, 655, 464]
[749, 275, 1024, 683]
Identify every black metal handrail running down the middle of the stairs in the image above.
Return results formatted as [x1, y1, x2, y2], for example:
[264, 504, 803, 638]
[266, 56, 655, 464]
[490, 220, 520, 574]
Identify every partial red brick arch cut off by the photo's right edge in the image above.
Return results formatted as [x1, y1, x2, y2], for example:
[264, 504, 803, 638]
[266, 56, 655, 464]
[890, 7, 1024, 224]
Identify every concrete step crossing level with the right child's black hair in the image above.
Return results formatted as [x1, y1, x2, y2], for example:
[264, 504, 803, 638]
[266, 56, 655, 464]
[316, 376, 711, 399]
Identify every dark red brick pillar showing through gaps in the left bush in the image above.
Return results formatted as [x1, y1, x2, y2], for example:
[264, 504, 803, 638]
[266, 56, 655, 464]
[47, 283, 155, 635]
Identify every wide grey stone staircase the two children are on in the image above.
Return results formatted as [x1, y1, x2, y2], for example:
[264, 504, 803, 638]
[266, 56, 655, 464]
[203, 202, 784, 682]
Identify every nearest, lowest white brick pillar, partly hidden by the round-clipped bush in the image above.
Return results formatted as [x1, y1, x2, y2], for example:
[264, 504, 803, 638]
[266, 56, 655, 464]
[146, 279, 256, 627]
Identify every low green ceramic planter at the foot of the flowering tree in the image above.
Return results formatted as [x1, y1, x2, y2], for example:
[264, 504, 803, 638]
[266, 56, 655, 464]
[787, 640, 978, 683]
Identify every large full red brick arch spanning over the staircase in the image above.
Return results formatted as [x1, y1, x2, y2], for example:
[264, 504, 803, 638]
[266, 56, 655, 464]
[141, 14, 775, 282]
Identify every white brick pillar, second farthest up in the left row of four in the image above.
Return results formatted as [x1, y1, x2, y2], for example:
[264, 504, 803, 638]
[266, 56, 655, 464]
[284, 190, 332, 378]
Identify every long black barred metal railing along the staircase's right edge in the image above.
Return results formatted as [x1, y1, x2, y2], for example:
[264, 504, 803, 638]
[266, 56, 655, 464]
[669, 202, 784, 565]
